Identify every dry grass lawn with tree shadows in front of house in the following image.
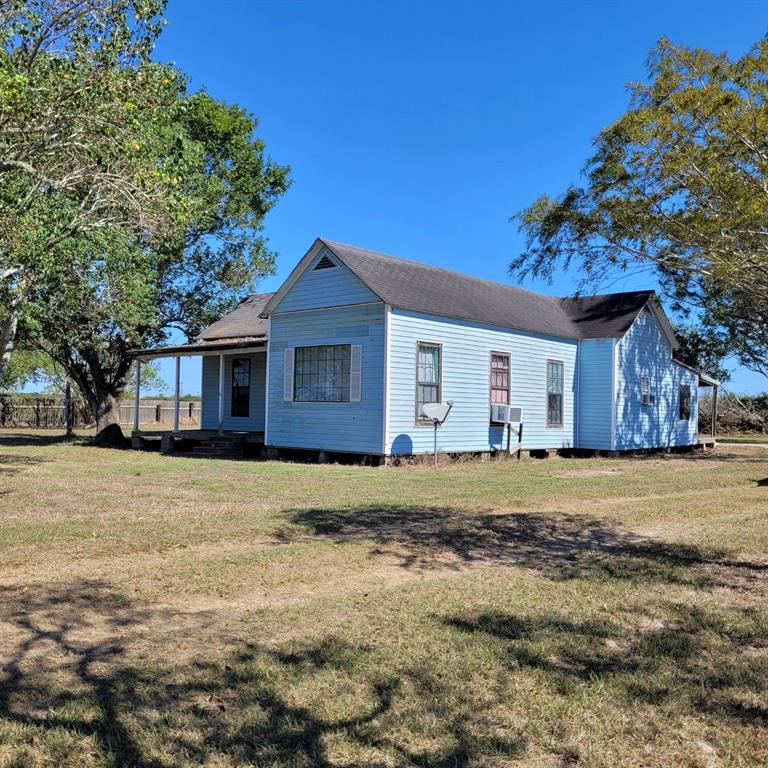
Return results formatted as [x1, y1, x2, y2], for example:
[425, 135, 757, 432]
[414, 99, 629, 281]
[0, 432, 768, 768]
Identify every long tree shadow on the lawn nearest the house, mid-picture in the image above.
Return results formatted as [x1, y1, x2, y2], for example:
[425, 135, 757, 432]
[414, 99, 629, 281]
[287, 506, 768, 586]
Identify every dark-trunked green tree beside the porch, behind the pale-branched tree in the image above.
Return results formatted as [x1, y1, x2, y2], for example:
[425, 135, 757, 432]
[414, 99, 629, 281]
[27, 91, 289, 427]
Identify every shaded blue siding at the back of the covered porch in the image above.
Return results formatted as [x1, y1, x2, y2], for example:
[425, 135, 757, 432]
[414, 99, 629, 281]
[201, 352, 267, 432]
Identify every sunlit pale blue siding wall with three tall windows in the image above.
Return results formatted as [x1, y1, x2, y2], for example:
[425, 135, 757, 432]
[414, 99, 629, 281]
[386, 308, 577, 454]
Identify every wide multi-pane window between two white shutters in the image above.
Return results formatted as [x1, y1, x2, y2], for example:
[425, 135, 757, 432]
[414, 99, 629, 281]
[293, 344, 352, 403]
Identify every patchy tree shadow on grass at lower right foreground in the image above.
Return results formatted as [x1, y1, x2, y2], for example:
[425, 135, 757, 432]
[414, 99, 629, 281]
[442, 604, 768, 727]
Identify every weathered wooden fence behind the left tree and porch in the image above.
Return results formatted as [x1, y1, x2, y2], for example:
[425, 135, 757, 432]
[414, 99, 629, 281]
[0, 395, 200, 429]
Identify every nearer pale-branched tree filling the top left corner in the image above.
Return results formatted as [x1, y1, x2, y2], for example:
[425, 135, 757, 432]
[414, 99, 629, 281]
[0, 0, 179, 381]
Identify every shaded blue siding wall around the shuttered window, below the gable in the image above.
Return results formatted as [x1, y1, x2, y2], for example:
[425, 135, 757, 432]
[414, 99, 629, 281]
[267, 304, 385, 454]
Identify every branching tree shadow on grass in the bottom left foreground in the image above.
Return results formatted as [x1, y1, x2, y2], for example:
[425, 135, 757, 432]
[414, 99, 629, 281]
[0, 581, 525, 768]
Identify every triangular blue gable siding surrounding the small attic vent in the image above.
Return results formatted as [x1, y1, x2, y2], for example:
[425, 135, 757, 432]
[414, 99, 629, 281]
[273, 248, 379, 312]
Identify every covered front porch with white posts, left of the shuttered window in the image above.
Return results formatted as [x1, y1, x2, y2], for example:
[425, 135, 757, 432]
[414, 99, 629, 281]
[131, 337, 267, 456]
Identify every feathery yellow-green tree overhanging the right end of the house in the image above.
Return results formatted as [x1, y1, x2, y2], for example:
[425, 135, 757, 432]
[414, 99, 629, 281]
[510, 39, 768, 375]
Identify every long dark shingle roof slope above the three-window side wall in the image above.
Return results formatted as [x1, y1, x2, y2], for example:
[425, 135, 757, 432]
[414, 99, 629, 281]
[321, 239, 653, 339]
